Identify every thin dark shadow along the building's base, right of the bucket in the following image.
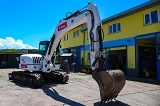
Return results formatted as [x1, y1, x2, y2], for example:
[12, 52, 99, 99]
[126, 77, 160, 85]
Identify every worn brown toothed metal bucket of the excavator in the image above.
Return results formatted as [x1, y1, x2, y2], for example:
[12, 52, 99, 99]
[92, 69, 125, 103]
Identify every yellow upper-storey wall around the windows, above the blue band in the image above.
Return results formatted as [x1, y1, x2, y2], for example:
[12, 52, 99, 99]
[61, 5, 160, 48]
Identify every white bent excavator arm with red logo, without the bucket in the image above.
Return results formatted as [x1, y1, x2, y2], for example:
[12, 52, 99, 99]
[43, 3, 103, 72]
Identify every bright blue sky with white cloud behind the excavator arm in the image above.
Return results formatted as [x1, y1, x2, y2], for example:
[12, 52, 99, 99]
[0, 0, 149, 49]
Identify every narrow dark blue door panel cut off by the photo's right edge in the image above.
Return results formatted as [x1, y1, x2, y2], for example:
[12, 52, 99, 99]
[157, 34, 160, 80]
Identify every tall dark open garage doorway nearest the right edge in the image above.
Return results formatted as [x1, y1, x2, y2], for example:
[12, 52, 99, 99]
[137, 37, 157, 79]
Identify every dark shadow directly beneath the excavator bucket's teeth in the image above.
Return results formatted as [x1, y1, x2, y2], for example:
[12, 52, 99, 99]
[94, 100, 129, 106]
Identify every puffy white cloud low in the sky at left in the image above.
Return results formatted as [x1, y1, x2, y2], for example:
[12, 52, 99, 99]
[0, 37, 37, 49]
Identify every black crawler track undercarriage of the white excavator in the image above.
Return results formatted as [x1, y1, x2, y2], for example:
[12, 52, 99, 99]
[9, 71, 69, 88]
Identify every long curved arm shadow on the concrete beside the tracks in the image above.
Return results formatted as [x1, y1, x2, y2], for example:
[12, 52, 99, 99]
[42, 85, 85, 106]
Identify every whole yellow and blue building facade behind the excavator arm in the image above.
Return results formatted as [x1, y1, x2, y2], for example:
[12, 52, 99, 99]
[61, 0, 160, 80]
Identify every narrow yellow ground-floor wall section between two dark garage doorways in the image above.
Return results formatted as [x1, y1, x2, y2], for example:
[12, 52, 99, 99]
[127, 46, 135, 68]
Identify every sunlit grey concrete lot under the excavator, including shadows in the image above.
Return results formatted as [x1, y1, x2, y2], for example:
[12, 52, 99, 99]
[0, 69, 160, 106]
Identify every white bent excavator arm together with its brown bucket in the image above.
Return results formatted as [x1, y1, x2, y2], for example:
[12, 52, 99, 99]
[43, 3, 125, 103]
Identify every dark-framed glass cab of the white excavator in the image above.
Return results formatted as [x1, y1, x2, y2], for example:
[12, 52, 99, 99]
[39, 41, 49, 56]
